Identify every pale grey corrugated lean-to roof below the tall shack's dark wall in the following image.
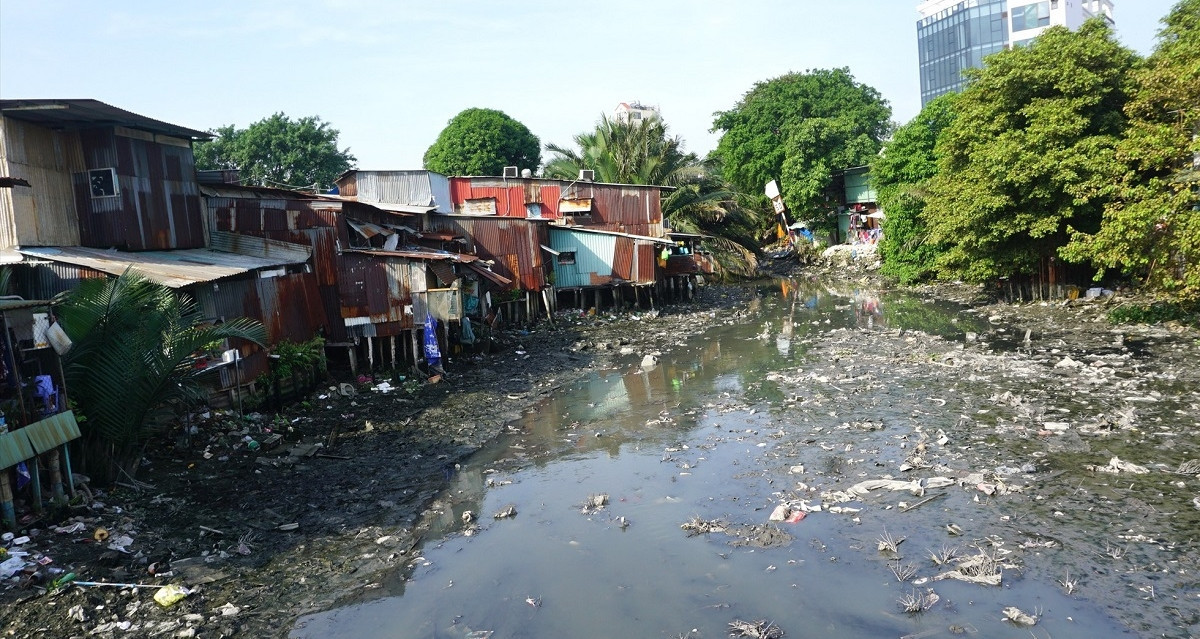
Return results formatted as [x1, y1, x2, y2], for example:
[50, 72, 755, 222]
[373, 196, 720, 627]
[20, 246, 307, 288]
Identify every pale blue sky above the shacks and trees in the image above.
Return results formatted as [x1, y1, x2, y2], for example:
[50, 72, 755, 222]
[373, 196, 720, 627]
[0, 0, 1174, 169]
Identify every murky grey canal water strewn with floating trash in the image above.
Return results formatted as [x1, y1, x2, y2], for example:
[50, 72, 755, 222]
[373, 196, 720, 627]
[292, 282, 1196, 639]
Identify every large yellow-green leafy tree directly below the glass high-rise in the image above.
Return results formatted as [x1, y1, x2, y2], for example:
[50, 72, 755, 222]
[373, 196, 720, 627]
[924, 19, 1136, 281]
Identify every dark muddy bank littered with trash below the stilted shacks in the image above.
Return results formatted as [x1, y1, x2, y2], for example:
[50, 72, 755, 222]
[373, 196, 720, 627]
[0, 287, 752, 638]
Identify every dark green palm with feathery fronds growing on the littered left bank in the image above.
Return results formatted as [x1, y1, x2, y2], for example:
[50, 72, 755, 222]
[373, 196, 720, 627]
[55, 266, 266, 480]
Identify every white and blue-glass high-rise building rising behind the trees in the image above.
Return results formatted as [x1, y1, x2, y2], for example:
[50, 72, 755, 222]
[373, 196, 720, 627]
[917, 0, 1112, 106]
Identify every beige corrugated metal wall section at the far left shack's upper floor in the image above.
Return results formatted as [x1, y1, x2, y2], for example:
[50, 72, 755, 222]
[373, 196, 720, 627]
[0, 118, 84, 246]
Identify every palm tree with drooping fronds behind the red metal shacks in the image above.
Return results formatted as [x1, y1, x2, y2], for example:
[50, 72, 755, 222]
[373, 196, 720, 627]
[542, 115, 756, 275]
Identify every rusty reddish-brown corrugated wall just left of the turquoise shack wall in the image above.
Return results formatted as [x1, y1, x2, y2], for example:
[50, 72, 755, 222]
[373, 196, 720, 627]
[428, 217, 548, 291]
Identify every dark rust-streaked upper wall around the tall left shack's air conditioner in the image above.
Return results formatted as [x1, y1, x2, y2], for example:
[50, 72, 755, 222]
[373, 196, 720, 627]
[73, 127, 205, 251]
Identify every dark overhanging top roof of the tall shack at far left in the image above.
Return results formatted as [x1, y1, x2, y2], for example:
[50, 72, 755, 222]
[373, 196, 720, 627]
[0, 100, 212, 139]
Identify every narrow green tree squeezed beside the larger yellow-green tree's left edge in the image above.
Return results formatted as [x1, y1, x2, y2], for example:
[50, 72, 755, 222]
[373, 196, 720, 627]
[871, 94, 959, 283]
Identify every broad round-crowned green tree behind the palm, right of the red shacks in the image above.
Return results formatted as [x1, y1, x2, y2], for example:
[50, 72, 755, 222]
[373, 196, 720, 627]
[713, 68, 892, 229]
